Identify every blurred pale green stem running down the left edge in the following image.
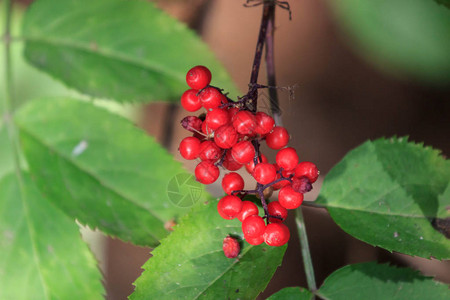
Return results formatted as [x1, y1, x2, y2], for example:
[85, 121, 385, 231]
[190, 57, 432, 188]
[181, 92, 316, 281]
[2, 0, 22, 184]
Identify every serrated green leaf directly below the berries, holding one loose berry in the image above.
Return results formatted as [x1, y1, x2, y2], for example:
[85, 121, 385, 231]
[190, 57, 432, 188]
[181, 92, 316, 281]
[130, 200, 286, 299]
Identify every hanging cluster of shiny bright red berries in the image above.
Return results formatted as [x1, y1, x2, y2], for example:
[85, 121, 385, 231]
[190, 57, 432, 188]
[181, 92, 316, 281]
[179, 66, 319, 253]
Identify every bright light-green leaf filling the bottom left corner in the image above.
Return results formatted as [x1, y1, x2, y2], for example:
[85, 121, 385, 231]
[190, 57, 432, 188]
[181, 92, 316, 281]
[0, 173, 104, 300]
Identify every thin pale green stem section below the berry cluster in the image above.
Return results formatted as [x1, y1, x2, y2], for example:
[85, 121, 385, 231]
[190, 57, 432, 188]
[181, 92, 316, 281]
[295, 207, 317, 293]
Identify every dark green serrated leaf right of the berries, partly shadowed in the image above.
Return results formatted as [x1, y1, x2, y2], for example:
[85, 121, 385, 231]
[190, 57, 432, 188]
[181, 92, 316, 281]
[317, 138, 450, 259]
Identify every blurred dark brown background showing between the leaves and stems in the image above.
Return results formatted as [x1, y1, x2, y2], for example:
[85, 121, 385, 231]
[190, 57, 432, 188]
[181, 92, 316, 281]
[16, 0, 450, 299]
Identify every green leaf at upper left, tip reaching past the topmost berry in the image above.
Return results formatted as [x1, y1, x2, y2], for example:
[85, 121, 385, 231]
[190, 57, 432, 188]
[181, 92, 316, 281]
[23, 0, 238, 102]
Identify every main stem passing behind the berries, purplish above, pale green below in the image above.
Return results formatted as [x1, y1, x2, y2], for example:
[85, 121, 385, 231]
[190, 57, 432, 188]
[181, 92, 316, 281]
[266, 3, 317, 292]
